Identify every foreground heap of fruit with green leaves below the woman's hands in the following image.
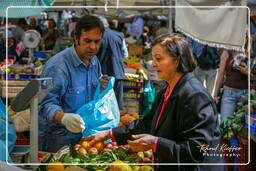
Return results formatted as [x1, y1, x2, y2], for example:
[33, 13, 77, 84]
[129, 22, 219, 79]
[38, 139, 154, 171]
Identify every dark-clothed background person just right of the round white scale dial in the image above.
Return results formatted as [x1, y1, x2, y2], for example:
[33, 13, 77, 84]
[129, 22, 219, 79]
[42, 18, 59, 50]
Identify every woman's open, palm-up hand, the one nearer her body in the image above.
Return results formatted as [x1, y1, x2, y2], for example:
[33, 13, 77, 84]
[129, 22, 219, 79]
[127, 134, 156, 152]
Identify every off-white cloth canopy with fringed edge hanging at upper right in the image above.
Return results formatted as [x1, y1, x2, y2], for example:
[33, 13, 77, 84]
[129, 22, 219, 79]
[175, 0, 249, 51]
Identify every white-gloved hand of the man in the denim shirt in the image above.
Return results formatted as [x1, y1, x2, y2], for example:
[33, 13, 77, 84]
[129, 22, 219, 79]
[61, 113, 85, 133]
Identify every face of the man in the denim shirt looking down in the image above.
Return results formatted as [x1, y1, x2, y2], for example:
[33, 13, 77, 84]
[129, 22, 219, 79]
[75, 28, 102, 60]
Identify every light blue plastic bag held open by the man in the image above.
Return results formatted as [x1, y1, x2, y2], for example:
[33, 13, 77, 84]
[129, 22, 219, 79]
[76, 77, 120, 137]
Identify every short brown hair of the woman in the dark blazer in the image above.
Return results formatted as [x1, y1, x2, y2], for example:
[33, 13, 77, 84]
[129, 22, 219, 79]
[152, 33, 196, 73]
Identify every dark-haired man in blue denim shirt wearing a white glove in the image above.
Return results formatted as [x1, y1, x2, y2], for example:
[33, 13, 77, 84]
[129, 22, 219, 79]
[39, 16, 104, 152]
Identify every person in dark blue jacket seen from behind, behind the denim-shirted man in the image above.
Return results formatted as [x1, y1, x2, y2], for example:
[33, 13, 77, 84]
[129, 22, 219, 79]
[97, 17, 128, 111]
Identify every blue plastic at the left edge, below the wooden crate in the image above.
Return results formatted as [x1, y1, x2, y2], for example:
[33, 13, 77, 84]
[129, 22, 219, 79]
[0, 99, 16, 162]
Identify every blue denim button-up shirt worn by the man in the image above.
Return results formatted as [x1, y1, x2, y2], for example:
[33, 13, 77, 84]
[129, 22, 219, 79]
[39, 47, 102, 136]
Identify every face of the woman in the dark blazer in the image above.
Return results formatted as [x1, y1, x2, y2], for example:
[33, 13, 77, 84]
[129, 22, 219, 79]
[152, 44, 179, 82]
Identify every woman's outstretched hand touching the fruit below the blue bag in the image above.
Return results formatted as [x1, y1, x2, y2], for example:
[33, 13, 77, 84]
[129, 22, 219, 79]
[85, 130, 111, 147]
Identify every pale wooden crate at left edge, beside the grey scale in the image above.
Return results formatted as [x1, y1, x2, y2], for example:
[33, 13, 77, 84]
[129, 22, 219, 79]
[0, 80, 29, 98]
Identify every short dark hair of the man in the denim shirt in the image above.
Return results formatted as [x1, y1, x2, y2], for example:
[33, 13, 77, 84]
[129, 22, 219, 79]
[75, 15, 105, 39]
